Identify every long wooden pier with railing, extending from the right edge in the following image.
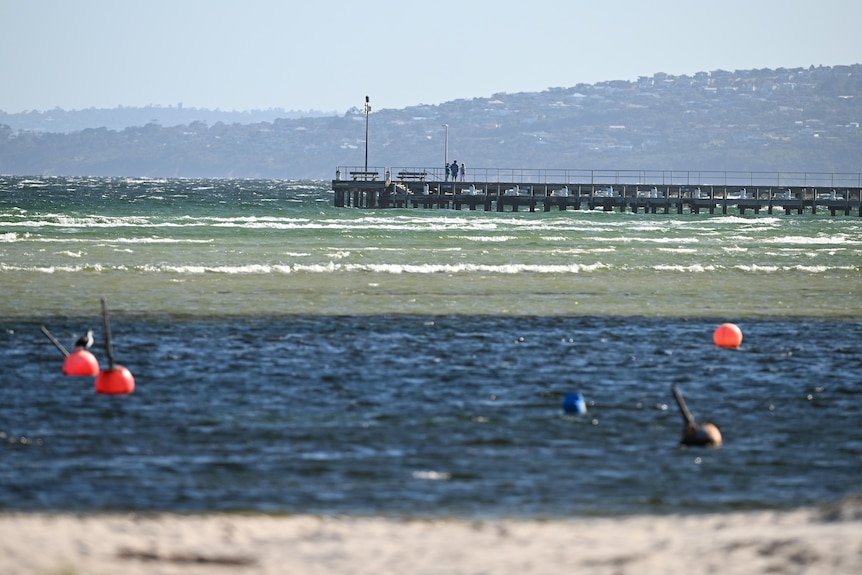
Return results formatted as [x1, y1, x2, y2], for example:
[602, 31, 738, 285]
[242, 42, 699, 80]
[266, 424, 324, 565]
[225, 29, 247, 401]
[332, 170, 862, 217]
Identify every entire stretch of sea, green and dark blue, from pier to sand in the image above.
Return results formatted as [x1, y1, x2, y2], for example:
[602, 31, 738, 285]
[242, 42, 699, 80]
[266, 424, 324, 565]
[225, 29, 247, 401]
[0, 176, 862, 517]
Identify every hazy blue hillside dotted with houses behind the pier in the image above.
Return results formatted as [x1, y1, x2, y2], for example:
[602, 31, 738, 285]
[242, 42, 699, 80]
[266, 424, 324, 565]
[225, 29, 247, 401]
[0, 64, 862, 179]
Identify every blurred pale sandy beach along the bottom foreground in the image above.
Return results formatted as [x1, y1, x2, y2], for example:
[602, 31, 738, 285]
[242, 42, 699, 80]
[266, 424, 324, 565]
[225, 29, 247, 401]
[0, 496, 862, 575]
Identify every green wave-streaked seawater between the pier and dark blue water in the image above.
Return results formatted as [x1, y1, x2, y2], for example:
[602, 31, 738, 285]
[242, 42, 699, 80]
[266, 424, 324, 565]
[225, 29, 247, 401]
[0, 177, 862, 319]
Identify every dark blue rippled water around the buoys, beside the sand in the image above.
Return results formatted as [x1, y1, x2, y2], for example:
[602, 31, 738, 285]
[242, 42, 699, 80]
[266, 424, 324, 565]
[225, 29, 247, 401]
[0, 315, 862, 517]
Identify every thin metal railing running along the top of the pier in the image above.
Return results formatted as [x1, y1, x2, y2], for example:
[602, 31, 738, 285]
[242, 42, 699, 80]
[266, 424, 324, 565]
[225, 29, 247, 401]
[336, 166, 862, 188]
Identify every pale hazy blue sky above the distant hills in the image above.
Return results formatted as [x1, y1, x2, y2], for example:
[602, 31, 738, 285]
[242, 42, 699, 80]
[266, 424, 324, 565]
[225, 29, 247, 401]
[0, 0, 862, 113]
